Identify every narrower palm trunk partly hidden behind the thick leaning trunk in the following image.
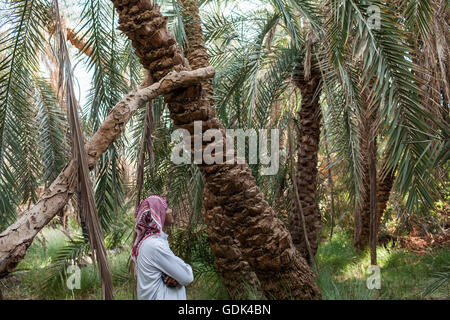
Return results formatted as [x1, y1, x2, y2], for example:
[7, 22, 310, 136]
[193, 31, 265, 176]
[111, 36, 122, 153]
[179, 0, 259, 300]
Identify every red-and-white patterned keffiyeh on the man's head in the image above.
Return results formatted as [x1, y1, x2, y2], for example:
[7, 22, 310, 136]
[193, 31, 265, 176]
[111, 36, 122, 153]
[131, 196, 167, 262]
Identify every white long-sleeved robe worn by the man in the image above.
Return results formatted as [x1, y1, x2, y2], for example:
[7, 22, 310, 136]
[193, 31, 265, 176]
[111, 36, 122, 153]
[137, 233, 194, 300]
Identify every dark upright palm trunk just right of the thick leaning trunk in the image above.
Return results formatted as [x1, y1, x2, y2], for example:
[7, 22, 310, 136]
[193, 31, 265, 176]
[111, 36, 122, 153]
[289, 66, 322, 260]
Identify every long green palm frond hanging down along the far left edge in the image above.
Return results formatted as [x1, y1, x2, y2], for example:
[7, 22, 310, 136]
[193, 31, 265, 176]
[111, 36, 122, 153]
[0, 0, 47, 215]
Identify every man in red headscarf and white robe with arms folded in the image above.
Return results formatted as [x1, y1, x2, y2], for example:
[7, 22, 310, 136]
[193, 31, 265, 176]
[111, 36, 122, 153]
[131, 196, 194, 300]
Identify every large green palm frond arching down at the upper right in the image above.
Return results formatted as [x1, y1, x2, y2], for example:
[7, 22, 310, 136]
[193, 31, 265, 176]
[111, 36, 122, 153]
[322, 0, 442, 209]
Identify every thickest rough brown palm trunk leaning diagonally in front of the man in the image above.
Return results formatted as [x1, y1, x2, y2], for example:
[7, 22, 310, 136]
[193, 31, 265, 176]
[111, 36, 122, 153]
[113, 0, 321, 299]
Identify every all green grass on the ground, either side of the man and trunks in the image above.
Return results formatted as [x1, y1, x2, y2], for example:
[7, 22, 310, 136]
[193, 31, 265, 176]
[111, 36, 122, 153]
[0, 228, 450, 300]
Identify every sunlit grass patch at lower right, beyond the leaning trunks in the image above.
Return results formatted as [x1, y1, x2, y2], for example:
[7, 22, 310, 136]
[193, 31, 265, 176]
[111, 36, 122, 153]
[316, 233, 450, 300]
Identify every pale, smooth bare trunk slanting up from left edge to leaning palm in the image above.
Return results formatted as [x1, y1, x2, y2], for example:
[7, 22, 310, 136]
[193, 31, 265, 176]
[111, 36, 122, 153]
[0, 67, 214, 278]
